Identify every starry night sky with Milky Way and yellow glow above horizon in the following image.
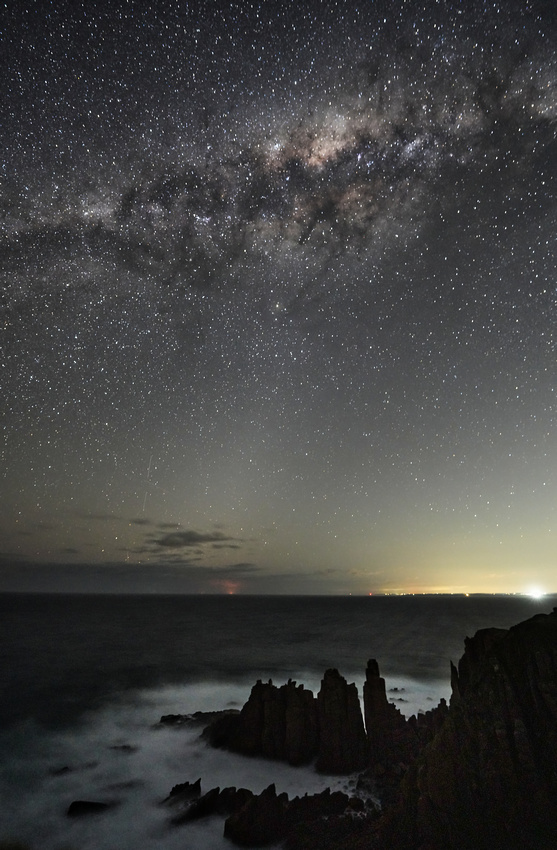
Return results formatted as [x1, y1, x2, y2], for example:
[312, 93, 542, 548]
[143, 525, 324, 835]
[0, 0, 557, 594]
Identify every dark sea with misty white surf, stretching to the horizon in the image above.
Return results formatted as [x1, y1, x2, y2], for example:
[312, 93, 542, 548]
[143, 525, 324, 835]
[0, 594, 557, 850]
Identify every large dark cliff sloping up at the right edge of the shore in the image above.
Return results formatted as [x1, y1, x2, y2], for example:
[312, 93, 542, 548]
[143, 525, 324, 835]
[381, 610, 557, 850]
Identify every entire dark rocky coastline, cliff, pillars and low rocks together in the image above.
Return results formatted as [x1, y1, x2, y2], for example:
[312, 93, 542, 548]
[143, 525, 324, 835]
[68, 609, 557, 850]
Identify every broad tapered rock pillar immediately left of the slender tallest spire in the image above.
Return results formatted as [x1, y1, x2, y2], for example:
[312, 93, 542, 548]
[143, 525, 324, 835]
[315, 670, 368, 773]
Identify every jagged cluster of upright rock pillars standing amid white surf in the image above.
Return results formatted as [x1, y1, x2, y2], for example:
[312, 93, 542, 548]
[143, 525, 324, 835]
[204, 660, 448, 786]
